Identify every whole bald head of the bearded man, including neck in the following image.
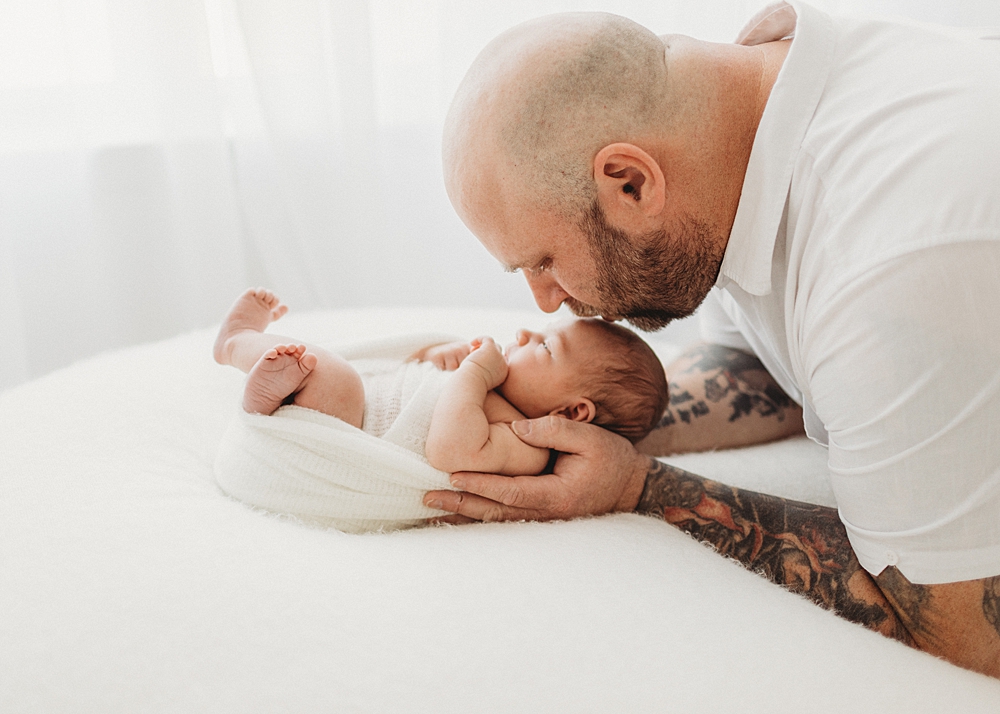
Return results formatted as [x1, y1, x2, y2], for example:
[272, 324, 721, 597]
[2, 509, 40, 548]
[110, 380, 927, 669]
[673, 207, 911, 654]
[443, 13, 760, 329]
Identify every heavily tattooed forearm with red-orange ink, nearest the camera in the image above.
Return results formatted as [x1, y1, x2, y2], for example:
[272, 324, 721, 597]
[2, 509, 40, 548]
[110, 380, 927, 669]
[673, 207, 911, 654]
[637, 461, 907, 640]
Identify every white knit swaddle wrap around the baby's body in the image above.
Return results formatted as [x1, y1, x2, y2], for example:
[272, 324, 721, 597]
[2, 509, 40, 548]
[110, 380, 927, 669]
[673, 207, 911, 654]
[215, 334, 456, 533]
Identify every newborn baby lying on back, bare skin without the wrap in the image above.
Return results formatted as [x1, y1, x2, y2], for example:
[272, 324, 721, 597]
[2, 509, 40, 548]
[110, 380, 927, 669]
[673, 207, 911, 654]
[214, 289, 667, 475]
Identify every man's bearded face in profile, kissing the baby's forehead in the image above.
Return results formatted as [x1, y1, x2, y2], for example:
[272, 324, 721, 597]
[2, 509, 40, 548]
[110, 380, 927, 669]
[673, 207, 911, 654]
[449, 145, 726, 331]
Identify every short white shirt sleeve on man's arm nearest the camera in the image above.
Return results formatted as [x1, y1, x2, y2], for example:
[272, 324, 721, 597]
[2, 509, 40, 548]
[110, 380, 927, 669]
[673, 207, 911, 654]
[798, 240, 1000, 584]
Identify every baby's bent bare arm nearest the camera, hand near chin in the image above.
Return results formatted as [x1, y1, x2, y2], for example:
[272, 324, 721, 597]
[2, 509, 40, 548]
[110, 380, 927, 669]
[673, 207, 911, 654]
[426, 337, 549, 476]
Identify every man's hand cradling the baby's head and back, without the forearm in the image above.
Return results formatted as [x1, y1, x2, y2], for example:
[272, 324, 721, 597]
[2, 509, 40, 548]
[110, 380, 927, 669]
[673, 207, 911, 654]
[424, 416, 650, 523]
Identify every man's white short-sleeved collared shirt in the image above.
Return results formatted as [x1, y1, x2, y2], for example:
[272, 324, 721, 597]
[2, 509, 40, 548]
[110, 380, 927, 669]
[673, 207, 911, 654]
[703, 2, 1000, 584]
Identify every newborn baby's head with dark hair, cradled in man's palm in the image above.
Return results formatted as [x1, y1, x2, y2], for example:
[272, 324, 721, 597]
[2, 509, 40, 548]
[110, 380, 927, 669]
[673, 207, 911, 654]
[498, 318, 667, 444]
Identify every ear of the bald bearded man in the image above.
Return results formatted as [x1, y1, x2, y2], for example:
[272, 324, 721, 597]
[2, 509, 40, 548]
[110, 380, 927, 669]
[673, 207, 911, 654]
[594, 143, 667, 222]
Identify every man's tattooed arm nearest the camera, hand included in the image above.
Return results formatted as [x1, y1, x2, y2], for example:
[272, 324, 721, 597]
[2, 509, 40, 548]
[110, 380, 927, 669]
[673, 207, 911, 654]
[424, 417, 1000, 678]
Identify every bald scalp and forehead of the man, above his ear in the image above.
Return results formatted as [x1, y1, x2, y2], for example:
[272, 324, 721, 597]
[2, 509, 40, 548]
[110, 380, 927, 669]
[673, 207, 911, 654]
[444, 13, 667, 217]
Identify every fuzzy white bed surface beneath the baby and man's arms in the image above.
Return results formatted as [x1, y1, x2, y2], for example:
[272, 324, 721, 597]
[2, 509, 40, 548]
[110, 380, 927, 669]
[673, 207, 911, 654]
[0, 309, 1000, 714]
